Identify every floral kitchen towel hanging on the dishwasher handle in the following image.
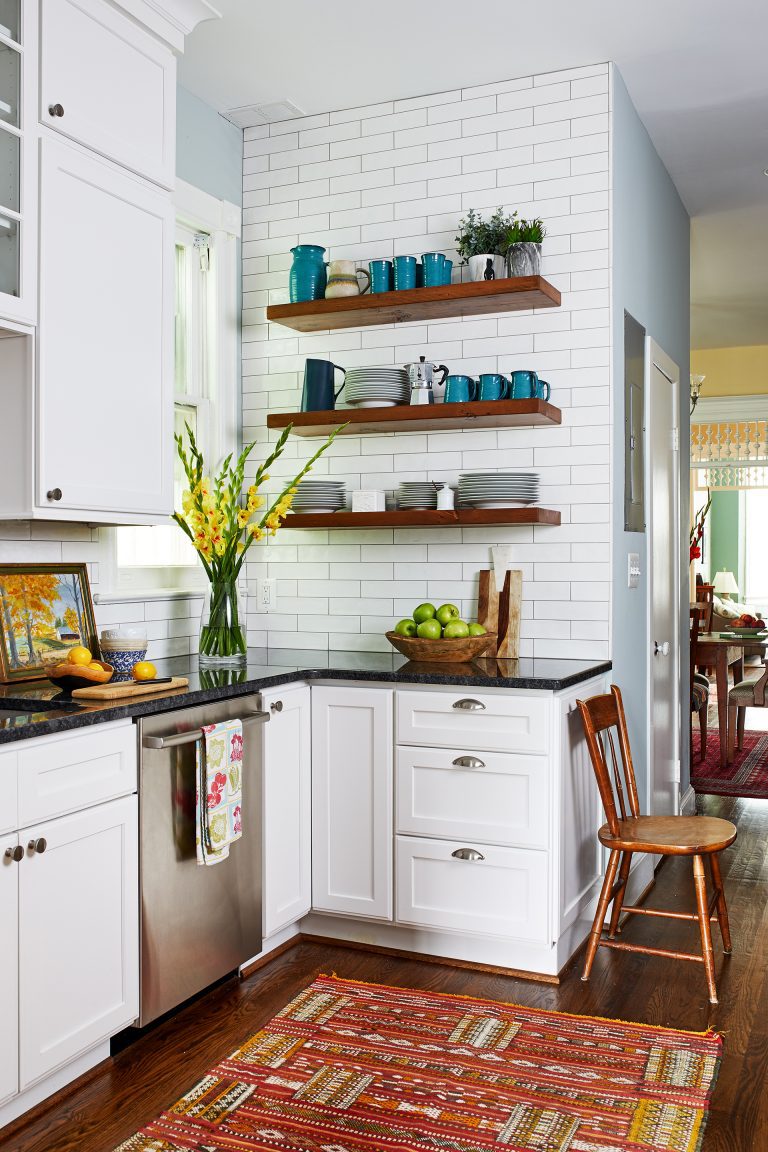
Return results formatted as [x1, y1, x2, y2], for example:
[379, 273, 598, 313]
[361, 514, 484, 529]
[195, 720, 243, 864]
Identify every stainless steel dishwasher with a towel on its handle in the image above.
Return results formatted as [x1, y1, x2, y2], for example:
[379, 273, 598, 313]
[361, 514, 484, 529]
[138, 696, 269, 1028]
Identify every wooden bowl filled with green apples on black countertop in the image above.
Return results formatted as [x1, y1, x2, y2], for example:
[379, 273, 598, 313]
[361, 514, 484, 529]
[385, 604, 496, 664]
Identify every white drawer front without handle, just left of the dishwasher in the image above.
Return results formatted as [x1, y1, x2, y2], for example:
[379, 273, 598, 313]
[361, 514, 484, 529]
[18, 722, 136, 827]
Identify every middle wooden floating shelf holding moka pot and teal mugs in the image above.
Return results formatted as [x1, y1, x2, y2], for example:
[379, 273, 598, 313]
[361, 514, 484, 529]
[267, 400, 562, 435]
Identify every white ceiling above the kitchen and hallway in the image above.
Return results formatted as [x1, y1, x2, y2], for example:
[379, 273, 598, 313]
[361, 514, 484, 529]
[180, 0, 768, 347]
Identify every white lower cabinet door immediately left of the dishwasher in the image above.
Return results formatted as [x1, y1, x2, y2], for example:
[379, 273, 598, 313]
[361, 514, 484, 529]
[18, 796, 138, 1089]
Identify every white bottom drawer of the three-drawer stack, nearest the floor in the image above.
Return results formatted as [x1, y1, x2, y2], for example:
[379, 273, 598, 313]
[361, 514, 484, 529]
[396, 836, 548, 943]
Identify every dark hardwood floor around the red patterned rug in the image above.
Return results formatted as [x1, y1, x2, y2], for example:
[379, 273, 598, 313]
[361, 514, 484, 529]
[0, 796, 768, 1152]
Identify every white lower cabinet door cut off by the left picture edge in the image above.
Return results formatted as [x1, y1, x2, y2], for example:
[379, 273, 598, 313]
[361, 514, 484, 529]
[0, 832, 20, 1104]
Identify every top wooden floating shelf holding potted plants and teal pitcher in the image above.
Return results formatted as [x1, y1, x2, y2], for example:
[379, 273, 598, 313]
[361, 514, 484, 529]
[267, 276, 560, 332]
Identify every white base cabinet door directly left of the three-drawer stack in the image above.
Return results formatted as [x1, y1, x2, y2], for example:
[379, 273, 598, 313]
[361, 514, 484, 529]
[312, 685, 393, 920]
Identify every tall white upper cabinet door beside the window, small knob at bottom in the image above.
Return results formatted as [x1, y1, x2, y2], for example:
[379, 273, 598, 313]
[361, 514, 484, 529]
[37, 138, 174, 522]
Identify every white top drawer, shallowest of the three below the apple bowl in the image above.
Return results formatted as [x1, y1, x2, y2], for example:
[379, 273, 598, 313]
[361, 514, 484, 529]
[397, 688, 552, 752]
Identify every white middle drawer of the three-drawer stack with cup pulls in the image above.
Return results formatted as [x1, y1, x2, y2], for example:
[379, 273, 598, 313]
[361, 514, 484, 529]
[396, 748, 549, 848]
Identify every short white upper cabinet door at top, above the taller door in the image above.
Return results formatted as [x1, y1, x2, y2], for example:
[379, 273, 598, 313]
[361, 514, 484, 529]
[40, 0, 176, 188]
